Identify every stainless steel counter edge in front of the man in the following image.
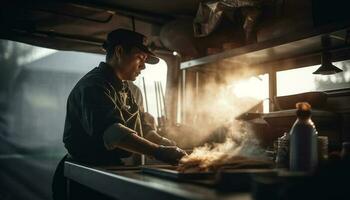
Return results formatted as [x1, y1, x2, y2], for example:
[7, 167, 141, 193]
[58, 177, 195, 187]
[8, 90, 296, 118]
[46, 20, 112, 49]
[65, 161, 252, 200]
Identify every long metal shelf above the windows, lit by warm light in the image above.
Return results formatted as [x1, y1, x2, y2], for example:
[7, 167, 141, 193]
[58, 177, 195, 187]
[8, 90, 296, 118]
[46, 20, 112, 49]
[180, 22, 350, 69]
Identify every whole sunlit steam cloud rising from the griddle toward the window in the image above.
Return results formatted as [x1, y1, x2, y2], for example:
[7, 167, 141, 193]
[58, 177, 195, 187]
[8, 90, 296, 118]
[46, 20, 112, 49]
[167, 63, 263, 171]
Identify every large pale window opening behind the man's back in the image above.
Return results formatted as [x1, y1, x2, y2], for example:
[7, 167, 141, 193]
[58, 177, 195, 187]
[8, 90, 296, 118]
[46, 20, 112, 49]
[0, 40, 108, 158]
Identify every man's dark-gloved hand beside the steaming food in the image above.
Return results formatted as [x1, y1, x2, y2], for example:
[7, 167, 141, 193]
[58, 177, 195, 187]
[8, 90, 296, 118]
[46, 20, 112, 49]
[154, 145, 187, 165]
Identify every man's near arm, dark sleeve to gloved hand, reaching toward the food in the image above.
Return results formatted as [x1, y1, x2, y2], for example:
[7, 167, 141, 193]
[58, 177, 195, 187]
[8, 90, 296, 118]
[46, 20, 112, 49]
[82, 85, 185, 163]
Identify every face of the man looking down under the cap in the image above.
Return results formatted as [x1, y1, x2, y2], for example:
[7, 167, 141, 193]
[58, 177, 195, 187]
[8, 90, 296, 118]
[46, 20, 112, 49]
[120, 48, 148, 81]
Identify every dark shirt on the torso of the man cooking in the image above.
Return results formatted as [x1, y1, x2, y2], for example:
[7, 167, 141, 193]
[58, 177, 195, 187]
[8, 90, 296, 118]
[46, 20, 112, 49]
[63, 62, 142, 165]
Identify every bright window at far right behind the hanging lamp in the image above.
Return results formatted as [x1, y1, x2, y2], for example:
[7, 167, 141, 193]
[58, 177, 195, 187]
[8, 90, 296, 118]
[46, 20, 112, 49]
[277, 60, 350, 96]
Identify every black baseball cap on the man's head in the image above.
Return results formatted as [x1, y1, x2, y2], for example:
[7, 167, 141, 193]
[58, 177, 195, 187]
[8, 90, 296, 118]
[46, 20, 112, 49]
[102, 28, 159, 64]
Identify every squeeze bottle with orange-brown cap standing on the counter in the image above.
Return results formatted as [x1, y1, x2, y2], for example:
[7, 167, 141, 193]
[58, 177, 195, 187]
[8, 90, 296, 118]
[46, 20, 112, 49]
[289, 102, 318, 172]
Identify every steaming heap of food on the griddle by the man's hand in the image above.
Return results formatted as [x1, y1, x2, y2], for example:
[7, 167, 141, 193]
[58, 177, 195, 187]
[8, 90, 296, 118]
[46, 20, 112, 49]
[178, 126, 273, 173]
